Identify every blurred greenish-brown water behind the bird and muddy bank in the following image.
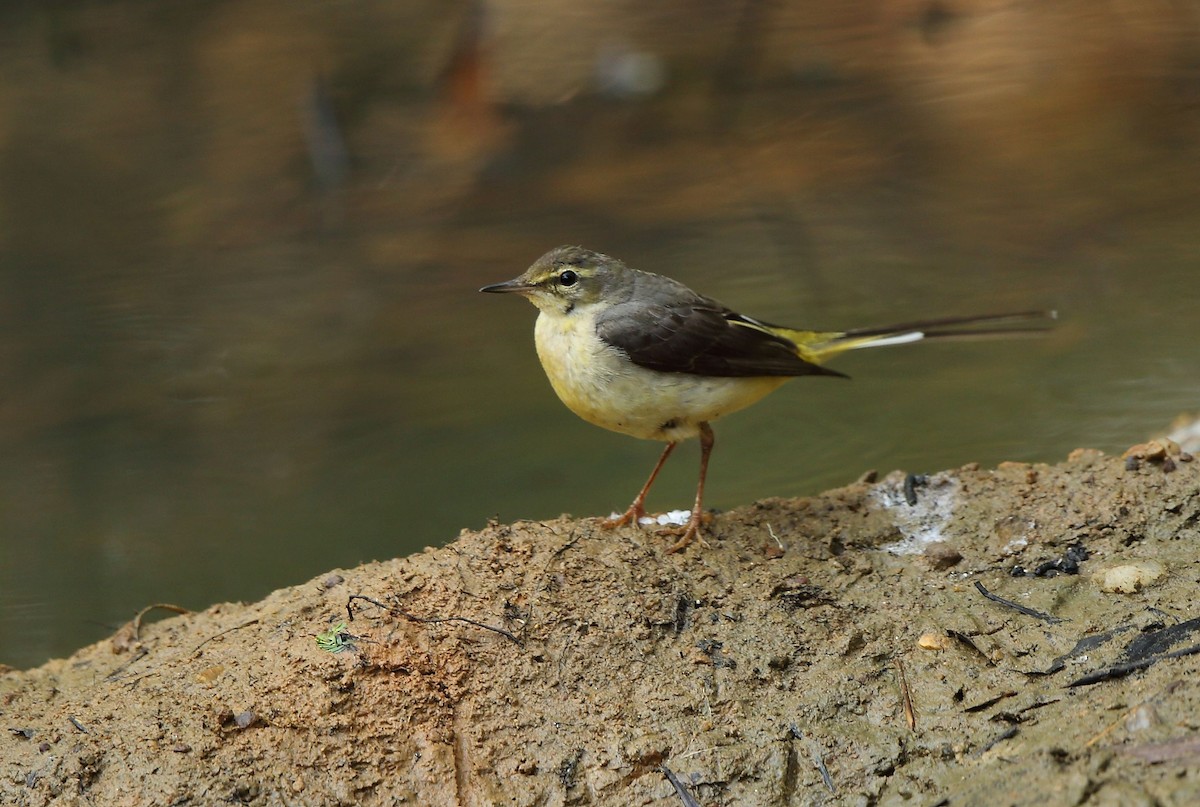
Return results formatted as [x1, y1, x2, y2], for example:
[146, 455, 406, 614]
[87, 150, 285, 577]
[0, 0, 1200, 666]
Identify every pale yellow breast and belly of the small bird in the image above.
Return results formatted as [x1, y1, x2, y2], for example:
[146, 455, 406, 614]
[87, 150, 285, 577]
[534, 315, 787, 442]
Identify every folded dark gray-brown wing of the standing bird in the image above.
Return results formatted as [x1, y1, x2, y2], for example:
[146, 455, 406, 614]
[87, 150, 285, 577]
[596, 295, 842, 377]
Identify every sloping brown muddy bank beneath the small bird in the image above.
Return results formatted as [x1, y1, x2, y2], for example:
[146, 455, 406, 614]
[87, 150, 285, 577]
[0, 444, 1200, 806]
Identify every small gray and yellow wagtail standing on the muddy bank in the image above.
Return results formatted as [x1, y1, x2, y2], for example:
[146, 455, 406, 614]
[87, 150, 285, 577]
[479, 246, 1055, 551]
